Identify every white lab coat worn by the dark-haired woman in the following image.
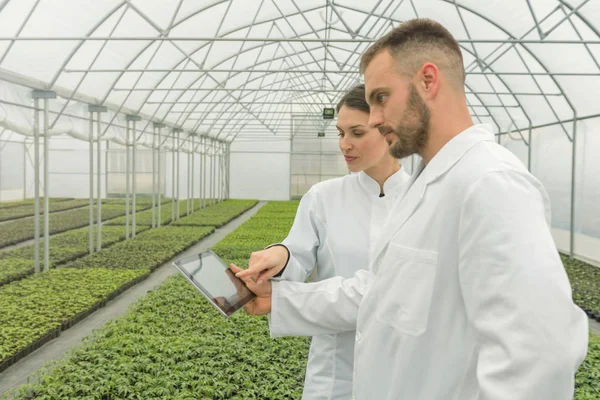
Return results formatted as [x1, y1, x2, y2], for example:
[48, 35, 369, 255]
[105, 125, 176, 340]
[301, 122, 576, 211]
[281, 168, 410, 400]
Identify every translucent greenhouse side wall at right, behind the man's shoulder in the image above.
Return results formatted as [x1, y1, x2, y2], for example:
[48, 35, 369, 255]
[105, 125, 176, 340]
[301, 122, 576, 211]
[501, 118, 600, 265]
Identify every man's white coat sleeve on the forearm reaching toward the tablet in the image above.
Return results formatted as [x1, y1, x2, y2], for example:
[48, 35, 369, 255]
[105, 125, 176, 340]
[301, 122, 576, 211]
[268, 270, 373, 337]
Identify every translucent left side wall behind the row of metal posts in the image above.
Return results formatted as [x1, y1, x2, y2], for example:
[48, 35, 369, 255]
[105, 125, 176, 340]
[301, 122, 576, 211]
[0, 136, 220, 201]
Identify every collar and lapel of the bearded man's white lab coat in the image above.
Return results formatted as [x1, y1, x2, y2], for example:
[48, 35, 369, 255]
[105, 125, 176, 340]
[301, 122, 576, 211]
[371, 125, 494, 272]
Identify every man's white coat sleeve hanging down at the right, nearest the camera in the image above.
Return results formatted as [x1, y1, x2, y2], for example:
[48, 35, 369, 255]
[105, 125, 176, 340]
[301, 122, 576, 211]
[458, 171, 588, 400]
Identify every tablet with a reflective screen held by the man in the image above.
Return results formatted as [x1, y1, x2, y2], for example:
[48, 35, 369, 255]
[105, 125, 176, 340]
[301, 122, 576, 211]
[173, 250, 256, 317]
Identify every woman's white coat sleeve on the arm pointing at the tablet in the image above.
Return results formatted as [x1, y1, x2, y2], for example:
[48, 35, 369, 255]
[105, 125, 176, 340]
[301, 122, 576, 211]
[281, 188, 325, 282]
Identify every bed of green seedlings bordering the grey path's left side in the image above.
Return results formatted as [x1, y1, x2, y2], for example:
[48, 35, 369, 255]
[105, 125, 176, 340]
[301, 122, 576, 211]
[0, 200, 256, 371]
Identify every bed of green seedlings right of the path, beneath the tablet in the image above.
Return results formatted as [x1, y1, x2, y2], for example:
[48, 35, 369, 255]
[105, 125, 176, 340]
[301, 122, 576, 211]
[4, 203, 309, 400]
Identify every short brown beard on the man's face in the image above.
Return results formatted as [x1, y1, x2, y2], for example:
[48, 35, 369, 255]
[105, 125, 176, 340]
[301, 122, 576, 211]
[379, 84, 431, 158]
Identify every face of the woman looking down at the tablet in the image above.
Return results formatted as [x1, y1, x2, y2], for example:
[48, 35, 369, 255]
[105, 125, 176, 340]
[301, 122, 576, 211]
[337, 106, 391, 172]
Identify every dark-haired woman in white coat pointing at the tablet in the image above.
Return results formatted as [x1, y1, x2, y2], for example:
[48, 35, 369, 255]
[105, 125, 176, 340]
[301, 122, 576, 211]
[237, 85, 409, 400]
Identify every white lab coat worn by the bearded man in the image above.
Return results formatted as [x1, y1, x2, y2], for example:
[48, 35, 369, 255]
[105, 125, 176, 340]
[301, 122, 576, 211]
[270, 126, 588, 400]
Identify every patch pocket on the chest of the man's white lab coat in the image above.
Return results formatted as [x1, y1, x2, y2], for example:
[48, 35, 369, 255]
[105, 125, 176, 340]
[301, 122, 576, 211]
[376, 243, 438, 336]
